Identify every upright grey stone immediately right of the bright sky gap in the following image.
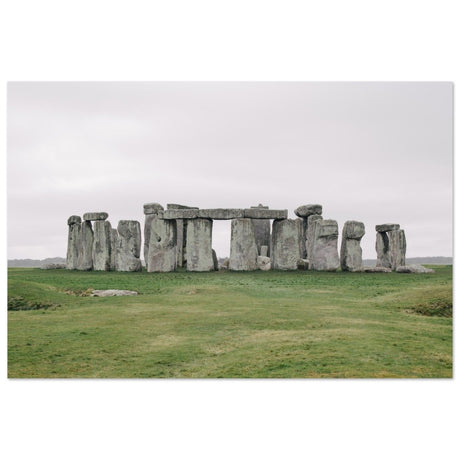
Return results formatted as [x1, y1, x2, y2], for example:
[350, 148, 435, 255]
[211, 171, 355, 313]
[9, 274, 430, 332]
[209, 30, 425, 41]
[229, 218, 258, 271]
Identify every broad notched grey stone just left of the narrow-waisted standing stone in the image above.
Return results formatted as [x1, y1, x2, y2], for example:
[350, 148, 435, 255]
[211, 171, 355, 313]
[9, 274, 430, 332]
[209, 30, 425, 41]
[308, 220, 340, 271]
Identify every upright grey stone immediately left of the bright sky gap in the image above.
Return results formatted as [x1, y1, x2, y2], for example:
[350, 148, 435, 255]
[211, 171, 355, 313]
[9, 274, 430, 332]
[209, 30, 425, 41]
[185, 218, 214, 272]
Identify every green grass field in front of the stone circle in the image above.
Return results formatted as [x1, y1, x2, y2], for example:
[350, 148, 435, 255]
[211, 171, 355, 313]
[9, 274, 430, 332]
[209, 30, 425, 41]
[8, 266, 452, 378]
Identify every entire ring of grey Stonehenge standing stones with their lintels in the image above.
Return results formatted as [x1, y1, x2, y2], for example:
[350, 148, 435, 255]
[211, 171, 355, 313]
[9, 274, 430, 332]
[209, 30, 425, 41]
[66, 203, 415, 273]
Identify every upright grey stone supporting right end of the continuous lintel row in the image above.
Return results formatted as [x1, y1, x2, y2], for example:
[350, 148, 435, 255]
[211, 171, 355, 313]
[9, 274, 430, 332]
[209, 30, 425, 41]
[271, 219, 302, 270]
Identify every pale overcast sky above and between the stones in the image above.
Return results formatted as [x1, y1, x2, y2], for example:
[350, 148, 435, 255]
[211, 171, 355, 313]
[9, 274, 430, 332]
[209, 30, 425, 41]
[7, 82, 453, 259]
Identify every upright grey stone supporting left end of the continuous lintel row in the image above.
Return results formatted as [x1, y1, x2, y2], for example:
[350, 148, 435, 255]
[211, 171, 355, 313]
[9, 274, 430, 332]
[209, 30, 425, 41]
[146, 216, 177, 272]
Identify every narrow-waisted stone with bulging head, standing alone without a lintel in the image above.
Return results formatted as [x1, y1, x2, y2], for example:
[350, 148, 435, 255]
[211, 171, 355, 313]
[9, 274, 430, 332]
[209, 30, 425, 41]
[340, 220, 365, 272]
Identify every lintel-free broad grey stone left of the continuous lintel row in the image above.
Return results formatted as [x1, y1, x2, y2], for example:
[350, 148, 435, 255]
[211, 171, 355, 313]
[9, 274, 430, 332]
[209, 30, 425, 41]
[115, 220, 142, 272]
